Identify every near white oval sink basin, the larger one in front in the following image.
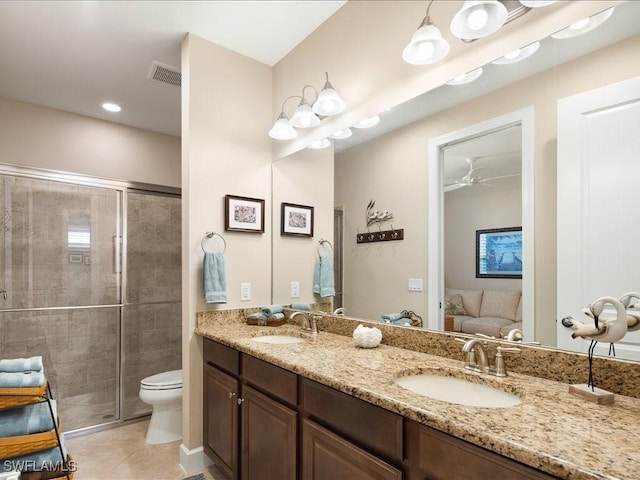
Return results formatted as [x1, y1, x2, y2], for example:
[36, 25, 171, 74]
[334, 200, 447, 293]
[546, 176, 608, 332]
[396, 374, 522, 408]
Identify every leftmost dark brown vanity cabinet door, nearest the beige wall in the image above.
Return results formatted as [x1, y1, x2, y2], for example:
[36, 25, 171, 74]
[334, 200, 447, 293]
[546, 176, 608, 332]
[203, 365, 238, 479]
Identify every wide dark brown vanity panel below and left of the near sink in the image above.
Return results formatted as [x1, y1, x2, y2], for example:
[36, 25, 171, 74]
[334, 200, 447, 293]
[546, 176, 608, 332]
[301, 378, 403, 462]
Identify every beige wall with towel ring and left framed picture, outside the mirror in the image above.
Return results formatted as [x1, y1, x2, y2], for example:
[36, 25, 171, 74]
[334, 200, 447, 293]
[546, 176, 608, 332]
[182, 34, 272, 449]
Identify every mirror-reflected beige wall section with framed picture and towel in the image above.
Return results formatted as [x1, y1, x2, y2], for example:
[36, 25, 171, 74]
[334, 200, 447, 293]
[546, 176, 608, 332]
[272, 148, 334, 304]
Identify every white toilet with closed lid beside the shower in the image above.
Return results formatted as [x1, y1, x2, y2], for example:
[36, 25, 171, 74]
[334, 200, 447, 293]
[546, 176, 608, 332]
[139, 370, 182, 444]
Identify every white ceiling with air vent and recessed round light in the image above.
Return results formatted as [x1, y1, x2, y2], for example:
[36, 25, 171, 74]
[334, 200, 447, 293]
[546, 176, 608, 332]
[0, 0, 346, 135]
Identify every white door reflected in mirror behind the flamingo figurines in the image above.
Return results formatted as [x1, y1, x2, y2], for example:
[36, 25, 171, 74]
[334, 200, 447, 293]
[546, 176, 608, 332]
[557, 77, 640, 360]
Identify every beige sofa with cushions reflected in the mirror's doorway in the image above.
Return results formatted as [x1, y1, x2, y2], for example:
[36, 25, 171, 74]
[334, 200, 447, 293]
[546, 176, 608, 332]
[444, 288, 522, 338]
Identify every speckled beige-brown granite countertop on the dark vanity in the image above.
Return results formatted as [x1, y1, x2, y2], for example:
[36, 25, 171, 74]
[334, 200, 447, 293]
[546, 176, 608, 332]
[195, 318, 640, 480]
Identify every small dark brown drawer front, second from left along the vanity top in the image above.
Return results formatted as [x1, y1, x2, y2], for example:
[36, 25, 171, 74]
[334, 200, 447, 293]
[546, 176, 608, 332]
[242, 354, 298, 406]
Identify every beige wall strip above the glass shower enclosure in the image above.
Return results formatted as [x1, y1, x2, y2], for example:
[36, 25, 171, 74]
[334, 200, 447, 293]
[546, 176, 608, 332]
[0, 97, 180, 187]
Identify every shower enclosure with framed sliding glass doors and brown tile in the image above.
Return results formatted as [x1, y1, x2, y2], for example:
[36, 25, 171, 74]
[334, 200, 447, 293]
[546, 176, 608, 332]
[0, 166, 181, 432]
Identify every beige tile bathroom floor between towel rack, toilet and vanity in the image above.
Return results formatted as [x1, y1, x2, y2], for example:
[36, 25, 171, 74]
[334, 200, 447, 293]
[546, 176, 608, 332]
[65, 420, 224, 480]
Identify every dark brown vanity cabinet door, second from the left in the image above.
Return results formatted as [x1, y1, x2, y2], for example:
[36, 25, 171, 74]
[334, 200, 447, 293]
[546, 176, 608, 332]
[241, 385, 298, 480]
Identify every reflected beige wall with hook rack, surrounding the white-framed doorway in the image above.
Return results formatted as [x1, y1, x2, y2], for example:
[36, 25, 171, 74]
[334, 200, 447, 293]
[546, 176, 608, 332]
[335, 36, 640, 345]
